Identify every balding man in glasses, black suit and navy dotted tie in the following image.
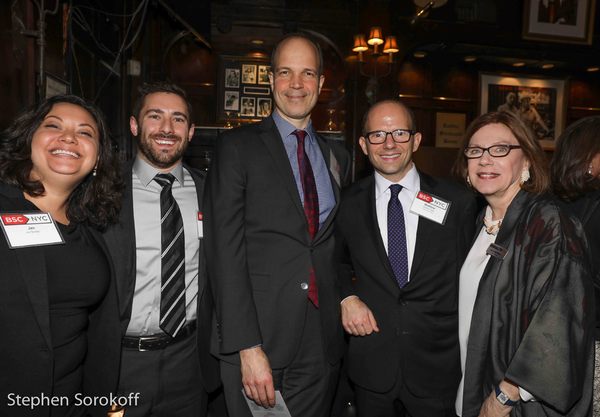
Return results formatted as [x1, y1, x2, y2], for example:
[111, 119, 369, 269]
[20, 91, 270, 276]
[336, 100, 475, 417]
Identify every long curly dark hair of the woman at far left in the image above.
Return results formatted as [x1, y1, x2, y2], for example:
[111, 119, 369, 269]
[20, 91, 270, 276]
[0, 95, 123, 230]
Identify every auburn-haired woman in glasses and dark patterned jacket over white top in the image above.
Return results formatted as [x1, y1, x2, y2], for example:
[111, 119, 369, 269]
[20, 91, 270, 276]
[455, 112, 594, 417]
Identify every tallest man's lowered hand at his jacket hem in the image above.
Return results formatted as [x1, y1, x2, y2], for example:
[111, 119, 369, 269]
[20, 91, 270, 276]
[240, 346, 275, 408]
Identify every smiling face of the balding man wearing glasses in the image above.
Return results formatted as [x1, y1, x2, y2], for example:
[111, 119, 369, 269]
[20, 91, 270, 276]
[358, 100, 421, 183]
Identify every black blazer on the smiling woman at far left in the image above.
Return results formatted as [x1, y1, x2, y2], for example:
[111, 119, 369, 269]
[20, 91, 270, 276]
[0, 184, 121, 417]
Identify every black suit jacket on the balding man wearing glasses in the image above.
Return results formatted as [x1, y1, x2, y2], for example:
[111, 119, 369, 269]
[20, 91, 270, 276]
[337, 173, 475, 398]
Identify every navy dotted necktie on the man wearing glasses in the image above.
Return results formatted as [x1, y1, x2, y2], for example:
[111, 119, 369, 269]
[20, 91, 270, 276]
[388, 184, 408, 288]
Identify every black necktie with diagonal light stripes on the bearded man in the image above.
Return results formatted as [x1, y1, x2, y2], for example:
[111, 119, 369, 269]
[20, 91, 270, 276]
[154, 174, 185, 337]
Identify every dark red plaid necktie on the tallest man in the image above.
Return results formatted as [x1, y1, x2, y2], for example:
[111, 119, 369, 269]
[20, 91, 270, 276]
[293, 130, 319, 307]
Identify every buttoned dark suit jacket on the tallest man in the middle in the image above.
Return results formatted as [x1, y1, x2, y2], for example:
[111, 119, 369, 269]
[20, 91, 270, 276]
[205, 117, 348, 368]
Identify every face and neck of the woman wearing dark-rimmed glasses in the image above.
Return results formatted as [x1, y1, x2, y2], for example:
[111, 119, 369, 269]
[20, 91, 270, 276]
[467, 123, 529, 214]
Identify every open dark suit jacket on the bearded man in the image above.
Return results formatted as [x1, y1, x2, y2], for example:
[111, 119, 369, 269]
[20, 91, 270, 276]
[104, 162, 220, 392]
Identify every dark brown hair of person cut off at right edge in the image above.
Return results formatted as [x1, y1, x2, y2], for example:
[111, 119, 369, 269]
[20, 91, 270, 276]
[550, 116, 600, 201]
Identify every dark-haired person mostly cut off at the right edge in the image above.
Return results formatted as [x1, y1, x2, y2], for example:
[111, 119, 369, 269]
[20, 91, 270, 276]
[550, 116, 600, 415]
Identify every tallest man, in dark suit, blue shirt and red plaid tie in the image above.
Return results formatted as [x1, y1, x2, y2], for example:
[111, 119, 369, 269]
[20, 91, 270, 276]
[205, 35, 346, 417]
